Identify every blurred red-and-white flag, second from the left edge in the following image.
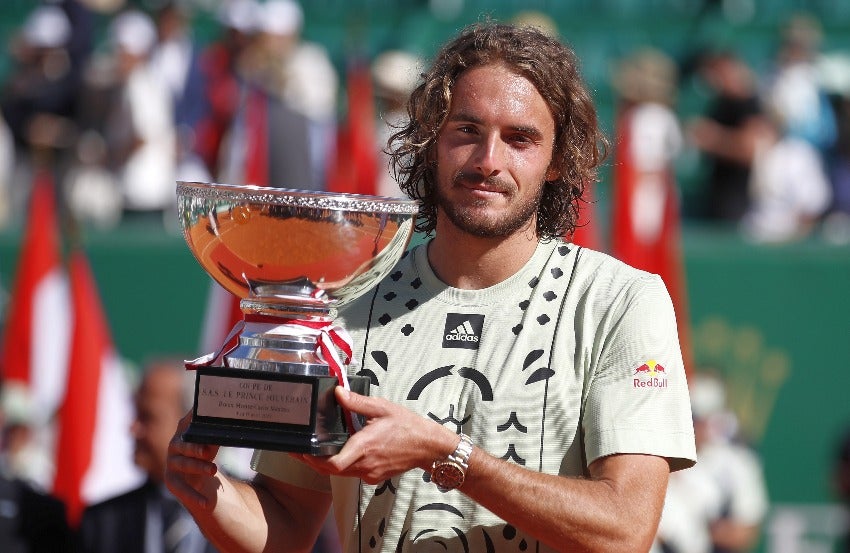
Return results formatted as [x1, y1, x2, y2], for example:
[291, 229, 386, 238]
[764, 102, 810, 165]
[53, 251, 141, 526]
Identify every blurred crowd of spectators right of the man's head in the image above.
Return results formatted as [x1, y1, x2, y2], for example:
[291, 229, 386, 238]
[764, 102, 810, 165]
[612, 8, 850, 243]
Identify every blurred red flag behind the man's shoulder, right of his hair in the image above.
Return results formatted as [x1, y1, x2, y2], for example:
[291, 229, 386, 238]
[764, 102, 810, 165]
[611, 105, 692, 371]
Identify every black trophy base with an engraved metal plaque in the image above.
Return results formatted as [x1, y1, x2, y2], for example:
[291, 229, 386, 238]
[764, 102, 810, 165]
[183, 367, 370, 455]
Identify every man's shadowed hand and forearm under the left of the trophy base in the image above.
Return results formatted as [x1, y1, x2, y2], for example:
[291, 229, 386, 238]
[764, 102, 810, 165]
[165, 413, 331, 553]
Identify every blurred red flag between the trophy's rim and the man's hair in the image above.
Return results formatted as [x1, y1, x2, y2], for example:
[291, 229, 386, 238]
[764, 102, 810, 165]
[327, 58, 379, 195]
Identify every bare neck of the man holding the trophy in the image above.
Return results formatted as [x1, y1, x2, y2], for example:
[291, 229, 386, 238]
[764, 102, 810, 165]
[428, 222, 538, 290]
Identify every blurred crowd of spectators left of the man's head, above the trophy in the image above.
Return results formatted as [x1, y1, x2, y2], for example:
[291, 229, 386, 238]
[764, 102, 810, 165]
[0, 0, 417, 233]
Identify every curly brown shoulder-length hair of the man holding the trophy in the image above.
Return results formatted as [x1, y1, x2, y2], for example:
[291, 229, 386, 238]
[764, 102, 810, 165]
[387, 21, 607, 239]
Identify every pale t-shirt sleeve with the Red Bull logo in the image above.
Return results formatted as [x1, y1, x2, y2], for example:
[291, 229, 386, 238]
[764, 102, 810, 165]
[582, 273, 696, 470]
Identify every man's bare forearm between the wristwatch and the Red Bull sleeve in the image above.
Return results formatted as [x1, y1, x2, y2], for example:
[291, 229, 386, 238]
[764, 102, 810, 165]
[461, 448, 667, 553]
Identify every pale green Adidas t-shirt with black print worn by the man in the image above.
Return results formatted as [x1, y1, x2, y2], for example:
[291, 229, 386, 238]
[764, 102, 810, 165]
[254, 240, 696, 551]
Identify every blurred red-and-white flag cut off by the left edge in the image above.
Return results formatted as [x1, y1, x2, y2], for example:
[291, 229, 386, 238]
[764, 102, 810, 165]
[0, 171, 70, 424]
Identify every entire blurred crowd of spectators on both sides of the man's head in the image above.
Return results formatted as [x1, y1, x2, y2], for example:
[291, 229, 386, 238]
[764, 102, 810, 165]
[0, 0, 850, 243]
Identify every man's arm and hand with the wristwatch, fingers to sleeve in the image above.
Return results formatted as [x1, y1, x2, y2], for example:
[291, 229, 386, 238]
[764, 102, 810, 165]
[302, 388, 669, 553]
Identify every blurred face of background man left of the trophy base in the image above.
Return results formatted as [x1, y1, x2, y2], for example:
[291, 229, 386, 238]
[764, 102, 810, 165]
[131, 369, 183, 481]
